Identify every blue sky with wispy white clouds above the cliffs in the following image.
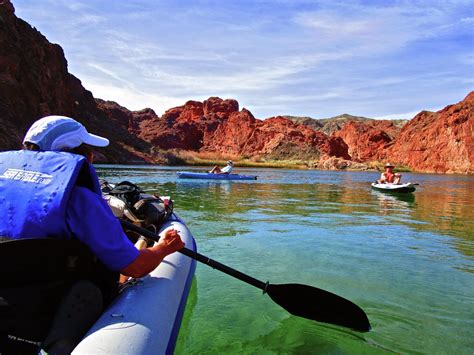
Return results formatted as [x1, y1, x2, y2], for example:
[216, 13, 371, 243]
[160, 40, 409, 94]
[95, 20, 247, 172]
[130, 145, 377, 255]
[13, 0, 474, 119]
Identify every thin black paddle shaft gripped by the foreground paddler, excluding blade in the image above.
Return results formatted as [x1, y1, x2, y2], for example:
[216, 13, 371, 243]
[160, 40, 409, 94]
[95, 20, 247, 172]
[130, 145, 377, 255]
[119, 219, 268, 293]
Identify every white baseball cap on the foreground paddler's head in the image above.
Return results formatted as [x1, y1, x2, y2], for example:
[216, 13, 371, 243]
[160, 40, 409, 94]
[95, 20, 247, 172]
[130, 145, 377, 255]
[23, 116, 109, 151]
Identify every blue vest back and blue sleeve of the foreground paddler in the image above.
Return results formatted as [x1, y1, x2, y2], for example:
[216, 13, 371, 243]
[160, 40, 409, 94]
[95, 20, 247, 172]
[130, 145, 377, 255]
[0, 150, 138, 271]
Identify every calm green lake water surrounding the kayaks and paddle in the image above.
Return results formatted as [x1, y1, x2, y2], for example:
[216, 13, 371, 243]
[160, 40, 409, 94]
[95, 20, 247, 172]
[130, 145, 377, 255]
[98, 166, 474, 354]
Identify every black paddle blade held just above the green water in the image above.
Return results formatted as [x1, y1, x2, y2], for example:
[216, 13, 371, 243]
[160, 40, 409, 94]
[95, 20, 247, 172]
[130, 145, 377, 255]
[266, 284, 370, 332]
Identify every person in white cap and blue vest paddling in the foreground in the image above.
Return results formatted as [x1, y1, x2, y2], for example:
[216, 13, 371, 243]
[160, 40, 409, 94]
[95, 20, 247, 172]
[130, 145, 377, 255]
[0, 116, 184, 354]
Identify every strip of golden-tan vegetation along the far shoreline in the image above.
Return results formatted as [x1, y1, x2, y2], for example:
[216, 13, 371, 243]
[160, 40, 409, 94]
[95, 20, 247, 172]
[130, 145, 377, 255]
[130, 150, 412, 172]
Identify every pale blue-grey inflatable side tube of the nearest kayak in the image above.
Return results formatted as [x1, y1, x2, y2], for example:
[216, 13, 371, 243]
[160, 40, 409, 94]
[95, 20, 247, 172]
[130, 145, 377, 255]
[73, 214, 196, 354]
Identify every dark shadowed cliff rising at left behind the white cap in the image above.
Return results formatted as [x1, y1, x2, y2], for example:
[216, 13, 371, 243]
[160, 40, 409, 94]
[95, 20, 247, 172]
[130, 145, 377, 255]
[0, 0, 151, 163]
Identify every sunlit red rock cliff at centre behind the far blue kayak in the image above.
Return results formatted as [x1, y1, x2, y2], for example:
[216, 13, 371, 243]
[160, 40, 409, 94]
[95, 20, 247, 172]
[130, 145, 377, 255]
[135, 97, 349, 160]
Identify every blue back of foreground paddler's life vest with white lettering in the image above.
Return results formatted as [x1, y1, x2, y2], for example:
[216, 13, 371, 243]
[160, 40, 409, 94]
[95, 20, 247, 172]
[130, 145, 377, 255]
[0, 150, 100, 239]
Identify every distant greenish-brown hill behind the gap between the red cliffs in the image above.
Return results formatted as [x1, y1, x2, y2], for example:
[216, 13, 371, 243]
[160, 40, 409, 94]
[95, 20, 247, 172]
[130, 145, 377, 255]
[283, 113, 408, 135]
